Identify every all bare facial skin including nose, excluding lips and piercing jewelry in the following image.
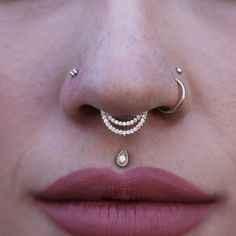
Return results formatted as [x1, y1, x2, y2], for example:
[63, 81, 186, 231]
[0, 0, 236, 236]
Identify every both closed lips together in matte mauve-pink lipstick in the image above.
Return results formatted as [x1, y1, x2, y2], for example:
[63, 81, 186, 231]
[38, 167, 213, 236]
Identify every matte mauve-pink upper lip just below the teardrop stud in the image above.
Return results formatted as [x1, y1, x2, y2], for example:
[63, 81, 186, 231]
[38, 167, 211, 203]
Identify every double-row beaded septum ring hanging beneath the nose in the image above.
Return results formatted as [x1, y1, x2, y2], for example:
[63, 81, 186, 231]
[101, 111, 148, 136]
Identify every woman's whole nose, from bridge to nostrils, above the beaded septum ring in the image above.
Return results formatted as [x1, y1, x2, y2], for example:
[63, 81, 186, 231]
[62, 1, 183, 119]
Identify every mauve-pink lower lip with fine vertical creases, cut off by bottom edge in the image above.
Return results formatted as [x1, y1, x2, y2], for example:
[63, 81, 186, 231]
[40, 200, 212, 236]
